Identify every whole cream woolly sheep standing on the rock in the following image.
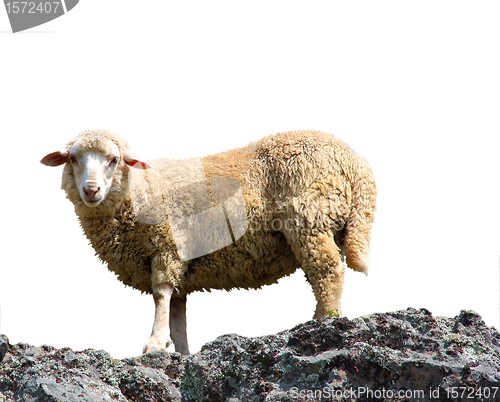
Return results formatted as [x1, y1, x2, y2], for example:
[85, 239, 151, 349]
[41, 130, 377, 355]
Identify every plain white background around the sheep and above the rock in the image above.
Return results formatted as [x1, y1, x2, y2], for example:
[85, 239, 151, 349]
[0, 0, 500, 358]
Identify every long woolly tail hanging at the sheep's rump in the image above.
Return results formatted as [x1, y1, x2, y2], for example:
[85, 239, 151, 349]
[344, 160, 377, 274]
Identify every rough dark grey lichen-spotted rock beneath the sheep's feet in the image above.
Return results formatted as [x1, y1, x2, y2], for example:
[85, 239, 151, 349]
[0, 308, 500, 402]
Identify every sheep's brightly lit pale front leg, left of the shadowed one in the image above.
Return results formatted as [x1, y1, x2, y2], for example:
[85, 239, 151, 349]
[143, 283, 174, 353]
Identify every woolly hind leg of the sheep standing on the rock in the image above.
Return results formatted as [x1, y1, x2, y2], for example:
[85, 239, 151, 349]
[292, 233, 345, 318]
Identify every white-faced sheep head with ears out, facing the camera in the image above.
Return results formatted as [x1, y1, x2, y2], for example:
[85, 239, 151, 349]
[40, 130, 151, 212]
